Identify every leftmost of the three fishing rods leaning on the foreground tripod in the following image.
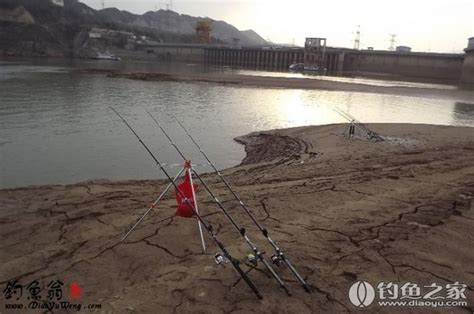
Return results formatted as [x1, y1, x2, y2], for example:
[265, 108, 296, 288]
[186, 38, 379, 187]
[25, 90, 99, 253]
[110, 107, 262, 299]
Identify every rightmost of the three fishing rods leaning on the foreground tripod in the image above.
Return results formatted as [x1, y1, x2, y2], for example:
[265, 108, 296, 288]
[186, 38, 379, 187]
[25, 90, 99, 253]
[172, 117, 311, 293]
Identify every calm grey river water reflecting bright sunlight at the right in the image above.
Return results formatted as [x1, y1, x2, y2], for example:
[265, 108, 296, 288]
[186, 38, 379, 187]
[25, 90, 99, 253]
[0, 60, 474, 188]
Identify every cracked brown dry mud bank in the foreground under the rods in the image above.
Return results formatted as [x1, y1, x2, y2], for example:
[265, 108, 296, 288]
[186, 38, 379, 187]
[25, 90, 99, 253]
[0, 124, 474, 313]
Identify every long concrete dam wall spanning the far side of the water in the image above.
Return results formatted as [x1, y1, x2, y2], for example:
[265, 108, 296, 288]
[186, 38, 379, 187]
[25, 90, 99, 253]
[146, 38, 474, 88]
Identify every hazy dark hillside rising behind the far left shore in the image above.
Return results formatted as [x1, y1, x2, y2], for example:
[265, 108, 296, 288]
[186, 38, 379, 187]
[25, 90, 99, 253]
[0, 0, 267, 56]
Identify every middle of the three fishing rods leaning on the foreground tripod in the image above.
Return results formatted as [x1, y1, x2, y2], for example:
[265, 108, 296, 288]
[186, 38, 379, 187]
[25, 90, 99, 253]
[147, 111, 291, 295]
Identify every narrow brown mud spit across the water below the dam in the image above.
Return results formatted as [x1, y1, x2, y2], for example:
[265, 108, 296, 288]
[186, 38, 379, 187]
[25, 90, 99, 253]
[79, 69, 474, 102]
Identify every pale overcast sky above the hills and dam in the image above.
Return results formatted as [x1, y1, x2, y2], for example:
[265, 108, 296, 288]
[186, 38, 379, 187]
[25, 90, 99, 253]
[82, 0, 474, 52]
